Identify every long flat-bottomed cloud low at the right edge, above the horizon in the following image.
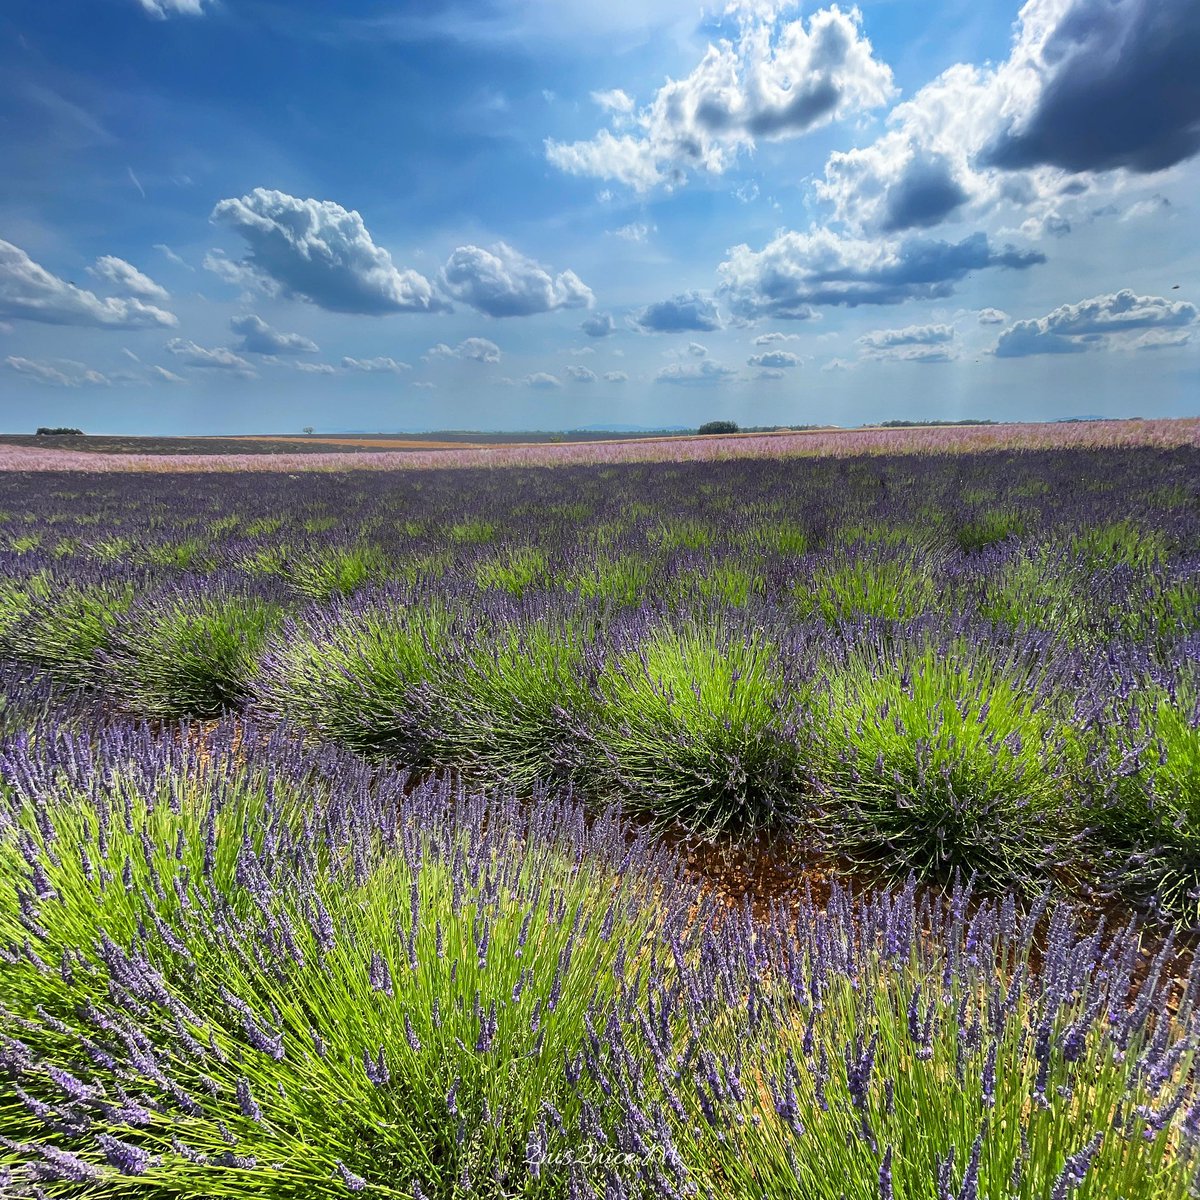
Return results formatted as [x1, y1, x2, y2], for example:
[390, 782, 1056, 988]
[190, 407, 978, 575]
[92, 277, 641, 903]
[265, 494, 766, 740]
[992, 288, 1200, 359]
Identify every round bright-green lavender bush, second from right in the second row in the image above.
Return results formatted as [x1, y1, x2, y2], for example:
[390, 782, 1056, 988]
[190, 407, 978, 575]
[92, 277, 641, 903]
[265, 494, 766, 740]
[810, 642, 1078, 884]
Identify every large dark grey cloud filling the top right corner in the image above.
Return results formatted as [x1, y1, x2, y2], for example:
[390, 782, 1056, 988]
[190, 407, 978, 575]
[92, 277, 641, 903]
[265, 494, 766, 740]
[982, 0, 1200, 173]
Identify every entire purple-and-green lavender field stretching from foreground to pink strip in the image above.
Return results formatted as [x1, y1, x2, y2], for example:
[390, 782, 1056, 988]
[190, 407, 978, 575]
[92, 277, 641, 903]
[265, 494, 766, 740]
[0, 444, 1200, 1200]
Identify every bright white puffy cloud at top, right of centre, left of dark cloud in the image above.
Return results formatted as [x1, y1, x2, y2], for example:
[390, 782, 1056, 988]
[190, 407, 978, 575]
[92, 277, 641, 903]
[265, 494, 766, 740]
[546, 5, 894, 191]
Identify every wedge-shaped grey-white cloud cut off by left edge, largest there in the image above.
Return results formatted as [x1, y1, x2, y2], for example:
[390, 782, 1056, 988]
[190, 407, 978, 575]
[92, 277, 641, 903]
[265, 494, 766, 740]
[0, 241, 179, 329]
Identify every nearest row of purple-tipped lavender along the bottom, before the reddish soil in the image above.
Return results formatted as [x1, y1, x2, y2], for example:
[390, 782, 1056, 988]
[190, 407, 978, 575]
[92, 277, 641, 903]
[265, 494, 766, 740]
[0, 719, 1200, 1200]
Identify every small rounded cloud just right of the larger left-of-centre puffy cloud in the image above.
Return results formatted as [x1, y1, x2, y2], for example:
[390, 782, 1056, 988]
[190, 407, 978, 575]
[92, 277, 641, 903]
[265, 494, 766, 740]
[442, 241, 593, 317]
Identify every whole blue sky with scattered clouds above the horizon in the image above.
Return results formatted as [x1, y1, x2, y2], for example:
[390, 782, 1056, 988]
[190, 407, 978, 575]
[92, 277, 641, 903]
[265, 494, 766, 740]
[0, 0, 1200, 433]
